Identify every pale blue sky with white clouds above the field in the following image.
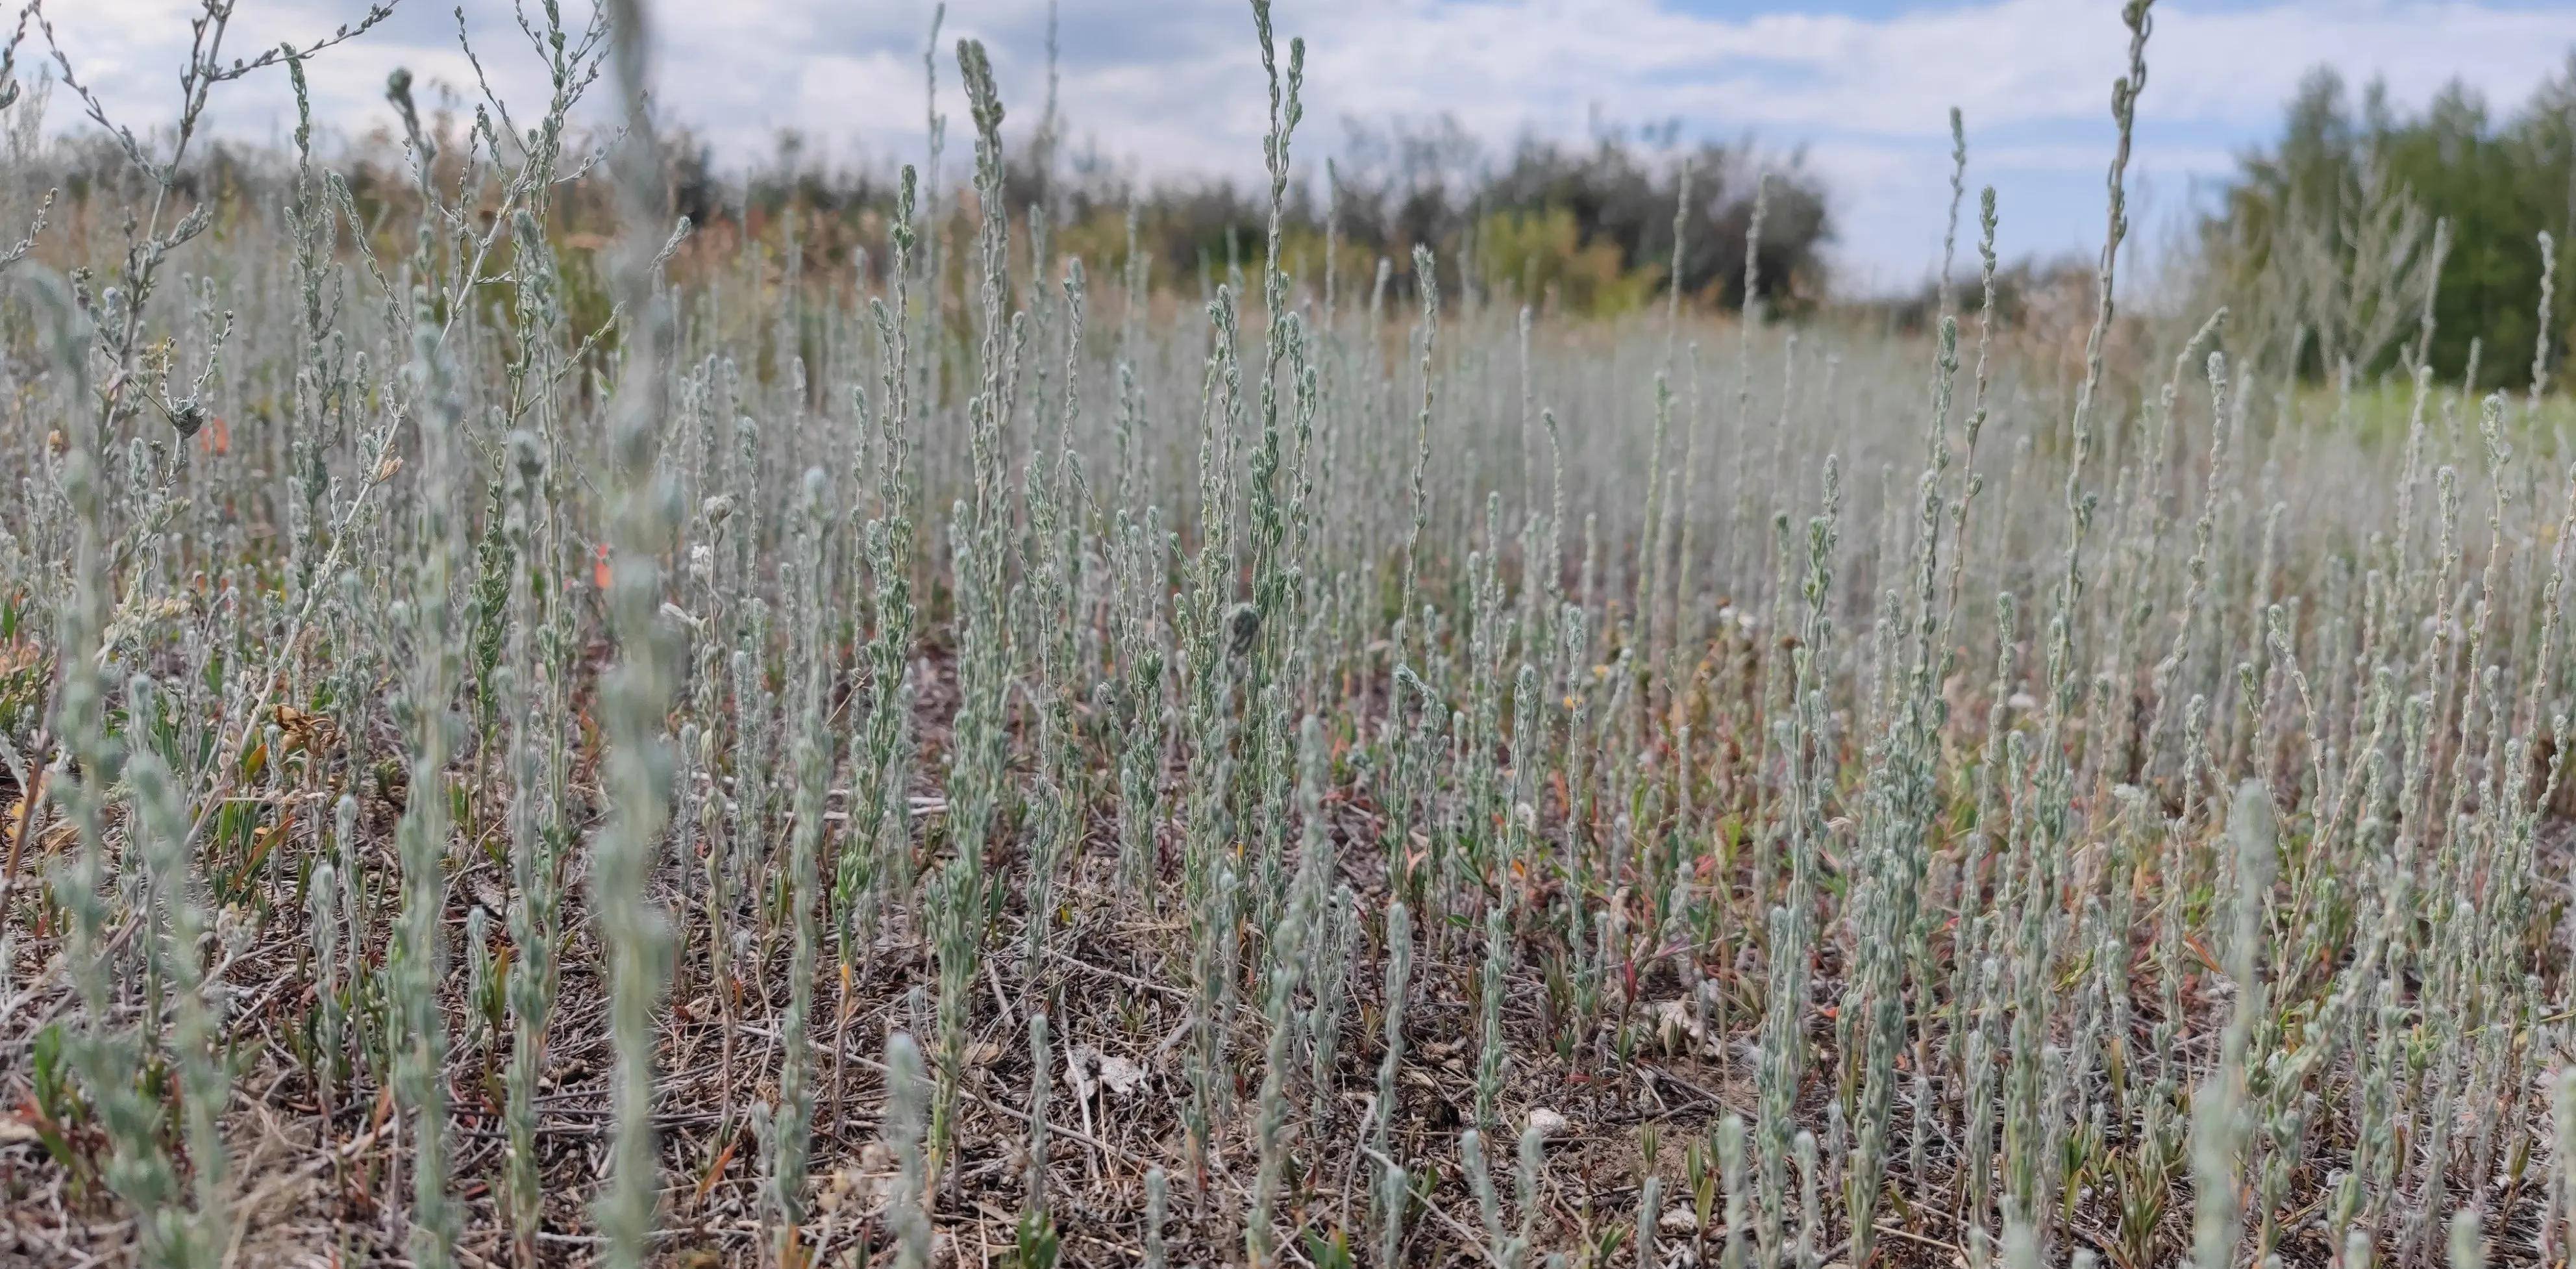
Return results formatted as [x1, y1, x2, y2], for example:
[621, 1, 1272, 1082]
[21, 0, 2576, 289]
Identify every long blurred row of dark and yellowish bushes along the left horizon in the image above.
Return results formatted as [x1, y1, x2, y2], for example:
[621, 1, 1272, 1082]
[18, 80, 1834, 325]
